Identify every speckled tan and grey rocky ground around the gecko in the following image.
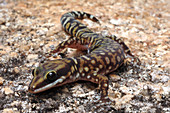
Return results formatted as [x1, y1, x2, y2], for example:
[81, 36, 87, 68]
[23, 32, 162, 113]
[0, 0, 170, 113]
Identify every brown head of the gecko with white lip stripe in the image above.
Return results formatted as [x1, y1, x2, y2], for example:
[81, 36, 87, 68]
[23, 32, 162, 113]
[28, 59, 70, 93]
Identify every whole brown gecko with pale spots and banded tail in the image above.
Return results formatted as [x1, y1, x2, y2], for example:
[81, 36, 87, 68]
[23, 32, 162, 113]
[29, 11, 138, 101]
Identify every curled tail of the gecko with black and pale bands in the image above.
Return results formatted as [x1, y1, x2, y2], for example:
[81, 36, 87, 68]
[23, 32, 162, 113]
[61, 11, 99, 37]
